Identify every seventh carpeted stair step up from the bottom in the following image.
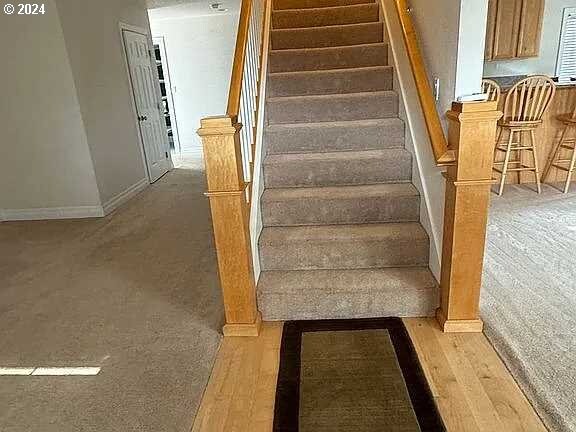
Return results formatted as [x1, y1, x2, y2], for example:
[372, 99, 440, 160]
[268, 66, 393, 97]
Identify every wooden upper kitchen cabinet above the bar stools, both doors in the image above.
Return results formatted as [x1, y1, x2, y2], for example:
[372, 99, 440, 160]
[485, 0, 545, 60]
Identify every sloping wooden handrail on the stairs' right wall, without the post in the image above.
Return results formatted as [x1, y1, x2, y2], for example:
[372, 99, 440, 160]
[394, 0, 456, 166]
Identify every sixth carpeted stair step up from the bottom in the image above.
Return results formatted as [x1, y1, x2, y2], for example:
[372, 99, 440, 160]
[267, 91, 398, 124]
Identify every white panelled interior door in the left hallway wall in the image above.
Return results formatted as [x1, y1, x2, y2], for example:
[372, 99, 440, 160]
[122, 30, 171, 182]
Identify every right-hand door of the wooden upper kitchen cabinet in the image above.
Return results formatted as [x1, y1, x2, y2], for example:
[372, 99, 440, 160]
[516, 0, 545, 57]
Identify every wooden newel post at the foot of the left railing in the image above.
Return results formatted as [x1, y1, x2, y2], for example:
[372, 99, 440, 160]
[198, 116, 261, 336]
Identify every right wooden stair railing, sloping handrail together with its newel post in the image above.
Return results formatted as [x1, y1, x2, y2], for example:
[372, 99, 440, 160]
[394, 0, 502, 332]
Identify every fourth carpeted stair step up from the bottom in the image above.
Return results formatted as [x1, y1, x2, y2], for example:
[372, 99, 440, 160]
[263, 148, 412, 188]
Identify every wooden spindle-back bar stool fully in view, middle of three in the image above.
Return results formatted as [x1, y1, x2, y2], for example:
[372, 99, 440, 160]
[494, 75, 556, 195]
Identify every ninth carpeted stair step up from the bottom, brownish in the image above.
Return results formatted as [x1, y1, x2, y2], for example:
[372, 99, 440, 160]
[271, 22, 383, 50]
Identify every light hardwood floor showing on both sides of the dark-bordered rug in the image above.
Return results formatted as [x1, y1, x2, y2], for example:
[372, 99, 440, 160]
[192, 318, 546, 432]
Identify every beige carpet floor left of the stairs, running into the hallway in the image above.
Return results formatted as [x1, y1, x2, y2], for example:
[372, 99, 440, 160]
[0, 154, 223, 432]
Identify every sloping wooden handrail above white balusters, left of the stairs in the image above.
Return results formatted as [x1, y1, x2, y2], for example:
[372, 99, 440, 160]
[226, 0, 252, 118]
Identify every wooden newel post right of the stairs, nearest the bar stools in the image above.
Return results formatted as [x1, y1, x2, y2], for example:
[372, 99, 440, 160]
[436, 102, 502, 332]
